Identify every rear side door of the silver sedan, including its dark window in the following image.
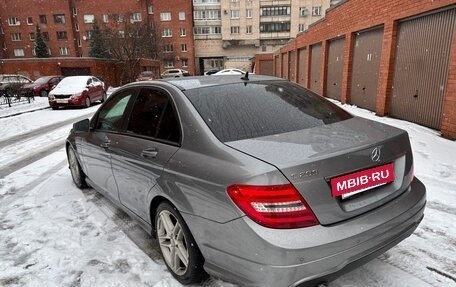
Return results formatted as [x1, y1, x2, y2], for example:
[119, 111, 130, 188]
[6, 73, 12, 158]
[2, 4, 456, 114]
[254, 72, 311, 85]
[110, 87, 181, 221]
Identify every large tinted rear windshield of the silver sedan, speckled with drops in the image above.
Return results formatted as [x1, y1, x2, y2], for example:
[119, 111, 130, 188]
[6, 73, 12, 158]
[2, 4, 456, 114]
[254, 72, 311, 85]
[185, 81, 352, 142]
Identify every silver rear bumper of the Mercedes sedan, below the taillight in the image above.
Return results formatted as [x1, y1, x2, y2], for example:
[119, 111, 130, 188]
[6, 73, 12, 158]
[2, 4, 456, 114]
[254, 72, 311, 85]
[184, 179, 426, 287]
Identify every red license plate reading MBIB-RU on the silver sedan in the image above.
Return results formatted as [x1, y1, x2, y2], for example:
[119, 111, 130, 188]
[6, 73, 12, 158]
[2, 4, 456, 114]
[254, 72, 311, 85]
[331, 163, 394, 198]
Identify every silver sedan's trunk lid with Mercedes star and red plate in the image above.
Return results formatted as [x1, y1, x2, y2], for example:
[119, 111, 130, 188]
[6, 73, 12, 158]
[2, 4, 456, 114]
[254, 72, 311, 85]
[226, 117, 413, 225]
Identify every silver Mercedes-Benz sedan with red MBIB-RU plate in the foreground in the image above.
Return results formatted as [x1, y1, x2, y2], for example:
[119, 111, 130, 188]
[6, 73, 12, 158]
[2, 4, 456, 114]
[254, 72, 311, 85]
[66, 74, 426, 287]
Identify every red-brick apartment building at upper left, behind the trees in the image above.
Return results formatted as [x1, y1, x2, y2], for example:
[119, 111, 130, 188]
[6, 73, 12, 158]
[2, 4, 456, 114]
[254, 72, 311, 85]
[0, 0, 195, 74]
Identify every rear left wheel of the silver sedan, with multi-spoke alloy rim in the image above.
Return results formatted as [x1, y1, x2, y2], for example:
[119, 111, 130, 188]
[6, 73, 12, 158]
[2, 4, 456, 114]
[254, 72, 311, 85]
[155, 202, 207, 284]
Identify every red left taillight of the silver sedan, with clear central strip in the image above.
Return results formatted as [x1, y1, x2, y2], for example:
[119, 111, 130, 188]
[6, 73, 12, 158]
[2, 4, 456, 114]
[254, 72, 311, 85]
[227, 184, 318, 229]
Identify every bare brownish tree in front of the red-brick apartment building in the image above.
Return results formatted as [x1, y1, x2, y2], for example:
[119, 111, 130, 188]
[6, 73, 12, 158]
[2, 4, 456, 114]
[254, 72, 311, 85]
[102, 15, 161, 83]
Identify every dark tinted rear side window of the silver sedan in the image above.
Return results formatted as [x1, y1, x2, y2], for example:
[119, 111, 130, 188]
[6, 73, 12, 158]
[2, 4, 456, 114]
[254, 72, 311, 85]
[127, 89, 180, 142]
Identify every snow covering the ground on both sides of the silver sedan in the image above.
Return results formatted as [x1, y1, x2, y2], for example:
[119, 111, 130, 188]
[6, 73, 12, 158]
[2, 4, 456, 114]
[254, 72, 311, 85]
[0, 95, 456, 287]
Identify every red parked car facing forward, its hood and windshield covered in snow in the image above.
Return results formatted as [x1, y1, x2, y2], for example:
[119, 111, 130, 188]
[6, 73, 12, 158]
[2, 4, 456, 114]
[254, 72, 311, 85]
[49, 76, 107, 110]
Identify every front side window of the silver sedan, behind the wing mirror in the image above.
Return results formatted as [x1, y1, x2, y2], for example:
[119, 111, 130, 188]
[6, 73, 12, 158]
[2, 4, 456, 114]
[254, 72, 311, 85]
[94, 91, 134, 131]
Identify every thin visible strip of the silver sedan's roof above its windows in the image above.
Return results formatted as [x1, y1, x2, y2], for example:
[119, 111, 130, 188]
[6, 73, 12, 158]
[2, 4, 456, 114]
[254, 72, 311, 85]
[125, 75, 286, 91]
